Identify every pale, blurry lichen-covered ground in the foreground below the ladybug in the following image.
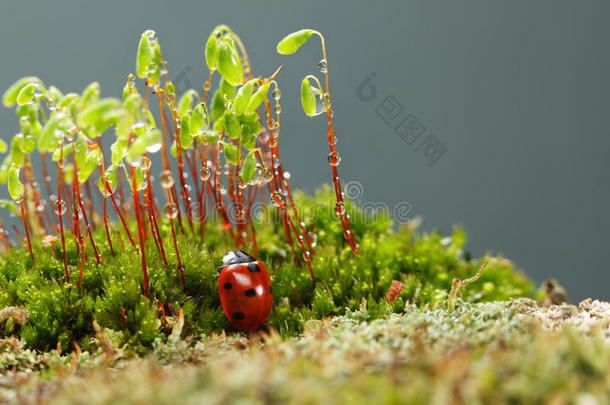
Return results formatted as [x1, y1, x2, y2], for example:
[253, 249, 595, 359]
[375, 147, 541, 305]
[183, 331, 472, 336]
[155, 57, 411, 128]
[0, 299, 610, 405]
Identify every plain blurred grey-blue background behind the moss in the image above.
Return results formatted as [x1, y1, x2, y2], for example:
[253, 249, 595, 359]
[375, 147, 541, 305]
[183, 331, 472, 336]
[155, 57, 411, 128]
[0, 0, 610, 301]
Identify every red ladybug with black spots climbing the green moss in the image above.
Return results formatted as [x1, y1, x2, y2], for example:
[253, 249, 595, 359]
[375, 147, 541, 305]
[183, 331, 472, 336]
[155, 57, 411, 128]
[217, 250, 273, 332]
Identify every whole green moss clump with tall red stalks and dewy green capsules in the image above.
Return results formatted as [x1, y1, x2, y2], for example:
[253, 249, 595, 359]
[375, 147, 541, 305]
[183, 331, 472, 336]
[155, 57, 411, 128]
[0, 25, 532, 348]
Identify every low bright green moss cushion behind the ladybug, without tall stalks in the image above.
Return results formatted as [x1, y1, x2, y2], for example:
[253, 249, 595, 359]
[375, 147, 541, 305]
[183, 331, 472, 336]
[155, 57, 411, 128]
[0, 189, 533, 350]
